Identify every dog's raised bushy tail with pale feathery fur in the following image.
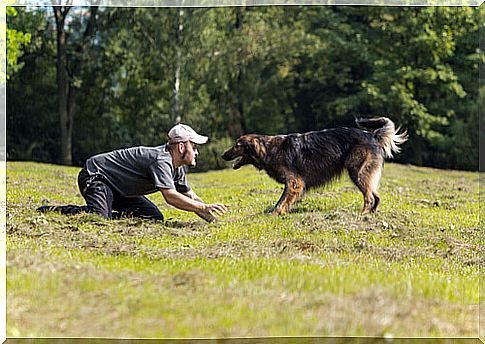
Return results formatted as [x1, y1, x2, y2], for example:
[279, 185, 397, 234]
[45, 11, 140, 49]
[355, 117, 408, 158]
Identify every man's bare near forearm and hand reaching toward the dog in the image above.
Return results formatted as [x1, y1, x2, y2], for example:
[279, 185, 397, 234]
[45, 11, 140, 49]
[160, 189, 227, 222]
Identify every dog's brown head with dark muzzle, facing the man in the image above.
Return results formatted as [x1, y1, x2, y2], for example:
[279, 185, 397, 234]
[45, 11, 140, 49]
[222, 134, 266, 170]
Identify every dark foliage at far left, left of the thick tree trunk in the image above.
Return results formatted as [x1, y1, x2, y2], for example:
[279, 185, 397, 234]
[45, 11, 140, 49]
[7, 7, 60, 162]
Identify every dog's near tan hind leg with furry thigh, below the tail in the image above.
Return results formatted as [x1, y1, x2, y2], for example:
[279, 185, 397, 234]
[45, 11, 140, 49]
[348, 152, 383, 214]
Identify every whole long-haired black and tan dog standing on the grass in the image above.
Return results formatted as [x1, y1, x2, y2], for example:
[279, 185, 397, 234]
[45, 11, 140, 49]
[222, 117, 408, 215]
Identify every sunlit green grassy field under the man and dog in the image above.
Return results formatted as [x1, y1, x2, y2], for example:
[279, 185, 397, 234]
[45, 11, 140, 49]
[6, 162, 485, 338]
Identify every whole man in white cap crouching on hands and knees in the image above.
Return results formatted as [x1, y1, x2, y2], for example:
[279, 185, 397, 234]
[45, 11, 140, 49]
[37, 124, 227, 222]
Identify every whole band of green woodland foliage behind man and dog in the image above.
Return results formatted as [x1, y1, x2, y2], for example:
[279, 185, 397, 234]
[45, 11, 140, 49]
[7, 6, 484, 170]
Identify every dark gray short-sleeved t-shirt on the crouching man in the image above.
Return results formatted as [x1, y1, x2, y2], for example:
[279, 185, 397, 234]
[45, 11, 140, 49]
[86, 145, 190, 197]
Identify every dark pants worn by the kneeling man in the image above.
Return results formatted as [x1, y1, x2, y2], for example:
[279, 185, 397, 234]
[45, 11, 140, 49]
[77, 168, 163, 221]
